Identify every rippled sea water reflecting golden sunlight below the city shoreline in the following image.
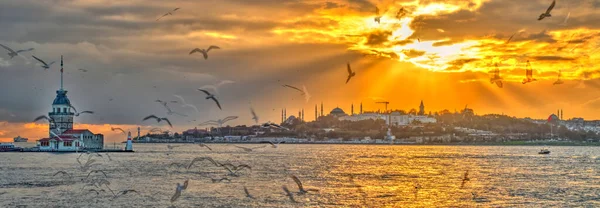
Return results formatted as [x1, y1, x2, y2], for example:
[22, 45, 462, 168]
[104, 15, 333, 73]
[0, 144, 600, 207]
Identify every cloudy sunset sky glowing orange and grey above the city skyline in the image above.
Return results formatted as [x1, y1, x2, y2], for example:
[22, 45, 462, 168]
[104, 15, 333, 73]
[0, 0, 600, 141]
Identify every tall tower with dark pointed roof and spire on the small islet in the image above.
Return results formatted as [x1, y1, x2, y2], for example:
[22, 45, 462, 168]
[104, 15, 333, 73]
[48, 56, 75, 137]
